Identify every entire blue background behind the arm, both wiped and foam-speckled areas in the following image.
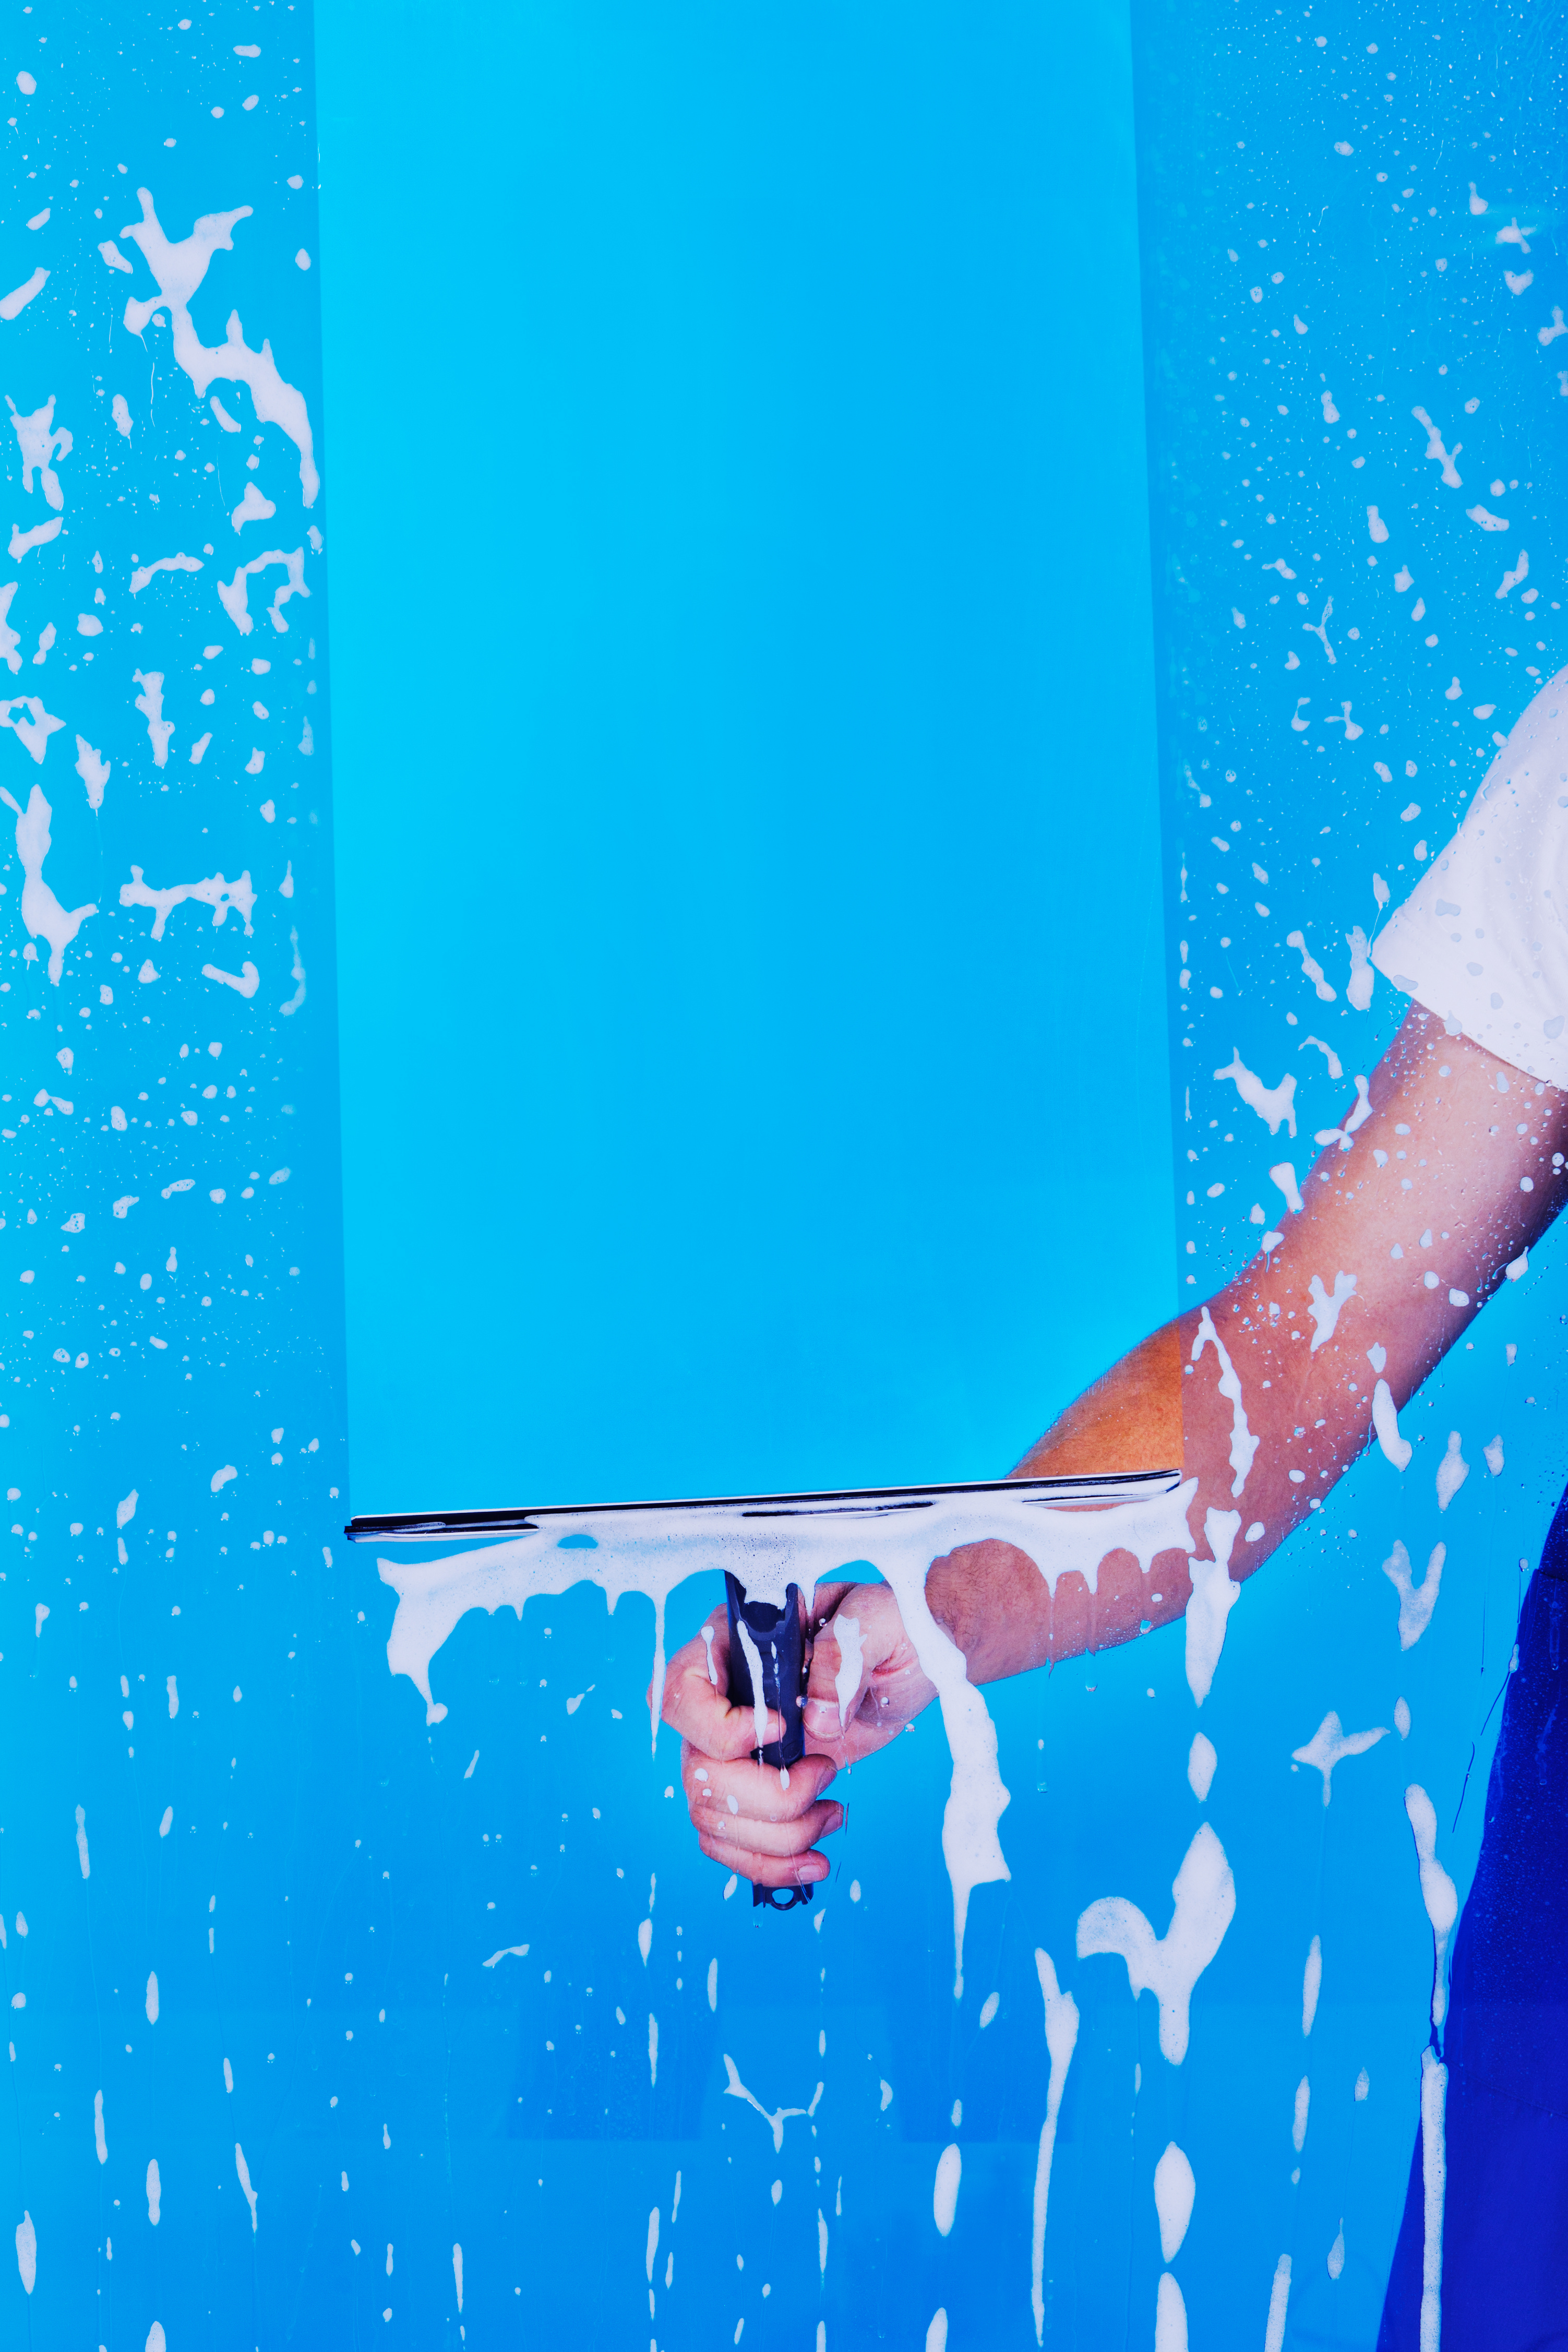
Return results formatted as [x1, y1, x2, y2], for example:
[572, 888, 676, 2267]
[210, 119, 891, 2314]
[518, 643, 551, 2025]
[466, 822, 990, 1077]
[0, 0, 1563, 2352]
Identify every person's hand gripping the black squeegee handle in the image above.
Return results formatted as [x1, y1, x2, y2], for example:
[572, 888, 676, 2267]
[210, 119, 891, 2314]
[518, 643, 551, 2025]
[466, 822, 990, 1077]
[663, 1583, 936, 1887]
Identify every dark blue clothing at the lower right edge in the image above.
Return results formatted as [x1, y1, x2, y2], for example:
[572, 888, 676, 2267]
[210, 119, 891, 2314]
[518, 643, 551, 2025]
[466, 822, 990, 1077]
[1378, 1496, 1568, 2352]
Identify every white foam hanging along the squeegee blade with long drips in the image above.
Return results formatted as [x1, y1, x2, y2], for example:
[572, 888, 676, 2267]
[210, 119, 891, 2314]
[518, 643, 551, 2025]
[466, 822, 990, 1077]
[376, 1477, 1189, 1999]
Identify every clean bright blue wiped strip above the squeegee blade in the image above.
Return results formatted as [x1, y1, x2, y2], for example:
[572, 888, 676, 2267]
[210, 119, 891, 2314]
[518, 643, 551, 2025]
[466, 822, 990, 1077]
[317, 0, 1173, 1510]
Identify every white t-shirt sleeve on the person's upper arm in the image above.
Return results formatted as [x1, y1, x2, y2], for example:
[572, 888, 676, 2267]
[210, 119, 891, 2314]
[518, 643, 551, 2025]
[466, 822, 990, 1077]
[1373, 670, 1568, 1091]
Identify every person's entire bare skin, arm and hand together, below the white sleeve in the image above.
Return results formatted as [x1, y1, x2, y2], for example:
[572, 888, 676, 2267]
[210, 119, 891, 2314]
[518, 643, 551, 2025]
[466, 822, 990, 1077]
[665, 1007, 1568, 1887]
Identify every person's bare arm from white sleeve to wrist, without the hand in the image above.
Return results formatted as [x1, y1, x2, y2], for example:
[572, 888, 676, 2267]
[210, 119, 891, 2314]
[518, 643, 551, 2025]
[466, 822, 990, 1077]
[926, 1011, 1568, 1682]
